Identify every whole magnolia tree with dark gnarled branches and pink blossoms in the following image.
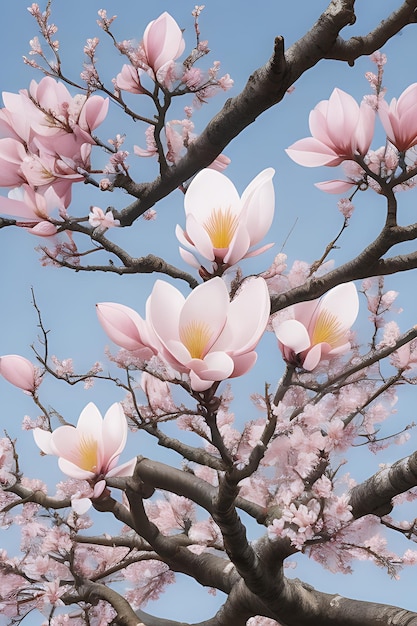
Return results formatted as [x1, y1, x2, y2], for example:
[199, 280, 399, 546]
[4, 0, 417, 626]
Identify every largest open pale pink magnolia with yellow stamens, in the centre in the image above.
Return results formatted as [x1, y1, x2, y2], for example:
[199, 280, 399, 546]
[147, 277, 270, 391]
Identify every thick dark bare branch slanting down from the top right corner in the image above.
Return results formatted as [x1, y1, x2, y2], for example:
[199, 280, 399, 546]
[116, 0, 417, 226]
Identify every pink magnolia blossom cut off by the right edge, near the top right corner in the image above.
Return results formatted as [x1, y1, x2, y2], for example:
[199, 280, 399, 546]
[378, 83, 417, 152]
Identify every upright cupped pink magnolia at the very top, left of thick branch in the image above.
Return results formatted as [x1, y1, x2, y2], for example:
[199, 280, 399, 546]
[142, 11, 185, 74]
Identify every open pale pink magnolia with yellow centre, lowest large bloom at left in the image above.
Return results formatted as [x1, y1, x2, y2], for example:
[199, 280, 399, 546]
[33, 402, 136, 513]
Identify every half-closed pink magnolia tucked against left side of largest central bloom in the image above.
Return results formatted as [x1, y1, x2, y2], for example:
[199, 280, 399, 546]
[96, 302, 159, 358]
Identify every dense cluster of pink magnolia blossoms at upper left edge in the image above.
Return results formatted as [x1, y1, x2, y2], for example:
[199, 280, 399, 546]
[0, 76, 108, 236]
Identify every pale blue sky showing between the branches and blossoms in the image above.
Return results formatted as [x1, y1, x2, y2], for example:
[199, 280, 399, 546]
[0, 0, 417, 624]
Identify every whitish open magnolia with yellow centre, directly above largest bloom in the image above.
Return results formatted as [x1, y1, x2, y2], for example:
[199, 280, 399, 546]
[176, 168, 275, 268]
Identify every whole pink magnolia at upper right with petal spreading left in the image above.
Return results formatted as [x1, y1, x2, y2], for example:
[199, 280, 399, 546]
[286, 89, 375, 167]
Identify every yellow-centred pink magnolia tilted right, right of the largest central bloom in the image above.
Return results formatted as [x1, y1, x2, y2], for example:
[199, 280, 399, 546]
[272, 283, 359, 371]
